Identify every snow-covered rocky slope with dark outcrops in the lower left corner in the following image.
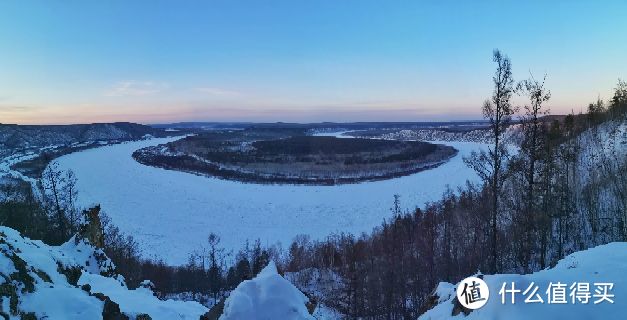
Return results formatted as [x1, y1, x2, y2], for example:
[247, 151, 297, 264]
[0, 227, 207, 320]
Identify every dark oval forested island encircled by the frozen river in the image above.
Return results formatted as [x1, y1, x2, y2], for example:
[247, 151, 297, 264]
[133, 129, 457, 185]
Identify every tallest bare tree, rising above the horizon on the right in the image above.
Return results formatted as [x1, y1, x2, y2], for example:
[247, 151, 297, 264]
[464, 49, 515, 272]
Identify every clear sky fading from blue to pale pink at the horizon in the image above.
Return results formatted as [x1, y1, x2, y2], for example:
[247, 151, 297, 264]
[0, 0, 627, 124]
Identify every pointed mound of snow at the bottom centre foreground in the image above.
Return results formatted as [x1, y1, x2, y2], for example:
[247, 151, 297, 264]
[220, 262, 314, 320]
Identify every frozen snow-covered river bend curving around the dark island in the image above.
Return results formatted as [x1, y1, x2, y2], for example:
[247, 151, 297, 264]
[57, 138, 485, 264]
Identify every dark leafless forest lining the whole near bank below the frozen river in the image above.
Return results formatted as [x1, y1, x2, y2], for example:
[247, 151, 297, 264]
[0, 51, 627, 319]
